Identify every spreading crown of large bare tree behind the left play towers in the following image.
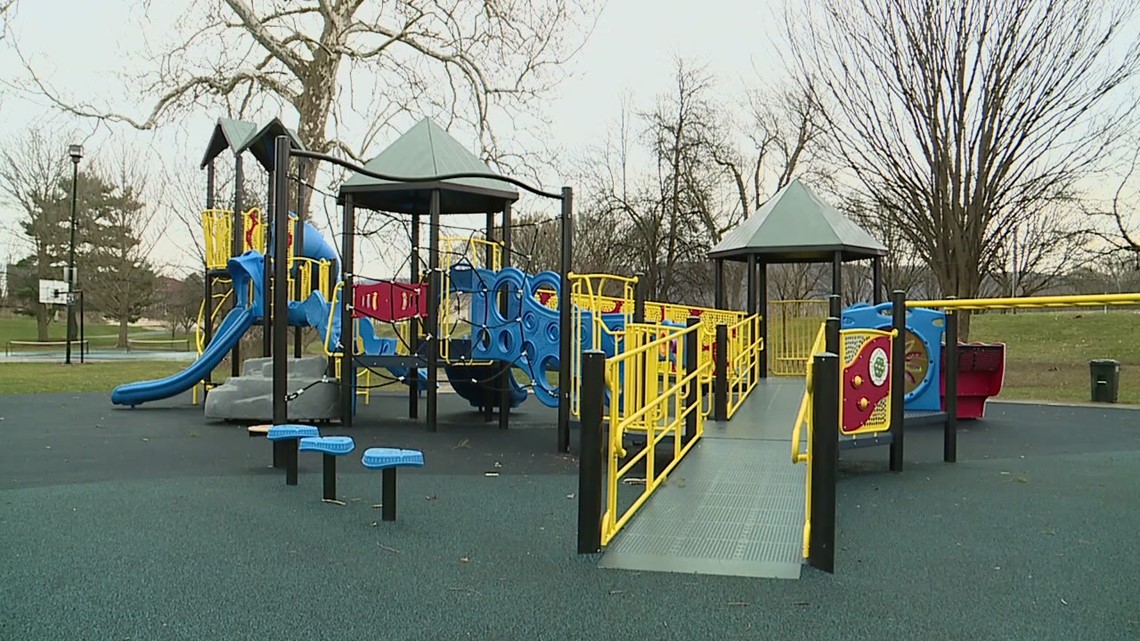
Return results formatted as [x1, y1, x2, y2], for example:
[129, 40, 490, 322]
[17, 0, 594, 210]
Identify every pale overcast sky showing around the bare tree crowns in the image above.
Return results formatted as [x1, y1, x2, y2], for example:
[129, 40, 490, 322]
[0, 0, 782, 280]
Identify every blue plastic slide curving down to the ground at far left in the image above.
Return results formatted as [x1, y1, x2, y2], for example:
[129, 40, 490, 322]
[111, 252, 262, 407]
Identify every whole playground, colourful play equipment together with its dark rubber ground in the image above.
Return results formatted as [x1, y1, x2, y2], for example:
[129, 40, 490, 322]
[0, 119, 1140, 640]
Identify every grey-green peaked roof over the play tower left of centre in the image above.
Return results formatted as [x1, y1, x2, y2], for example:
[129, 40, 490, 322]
[337, 119, 519, 213]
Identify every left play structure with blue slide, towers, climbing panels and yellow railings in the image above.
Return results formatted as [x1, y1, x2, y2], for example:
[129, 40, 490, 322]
[112, 114, 763, 451]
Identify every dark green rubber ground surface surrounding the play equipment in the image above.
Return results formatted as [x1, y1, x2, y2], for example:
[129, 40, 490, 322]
[0, 393, 1140, 641]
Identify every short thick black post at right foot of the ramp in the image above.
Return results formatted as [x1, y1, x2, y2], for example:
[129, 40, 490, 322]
[807, 352, 839, 573]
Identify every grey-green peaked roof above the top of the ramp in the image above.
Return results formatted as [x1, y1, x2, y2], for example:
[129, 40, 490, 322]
[709, 178, 887, 263]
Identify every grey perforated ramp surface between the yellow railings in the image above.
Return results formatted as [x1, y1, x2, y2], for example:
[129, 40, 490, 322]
[599, 378, 806, 578]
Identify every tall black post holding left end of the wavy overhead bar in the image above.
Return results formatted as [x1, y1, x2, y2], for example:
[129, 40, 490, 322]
[272, 136, 296, 435]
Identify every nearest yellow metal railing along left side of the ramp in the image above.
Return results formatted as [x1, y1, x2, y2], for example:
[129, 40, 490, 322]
[602, 326, 705, 545]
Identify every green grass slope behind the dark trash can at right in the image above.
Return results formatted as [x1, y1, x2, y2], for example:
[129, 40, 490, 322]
[970, 310, 1140, 404]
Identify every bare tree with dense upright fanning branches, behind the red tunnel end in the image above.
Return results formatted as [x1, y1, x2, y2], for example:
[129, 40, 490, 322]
[792, 0, 1140, 334]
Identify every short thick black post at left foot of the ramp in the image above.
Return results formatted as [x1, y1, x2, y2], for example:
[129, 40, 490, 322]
[578, 349, 606, 554]
